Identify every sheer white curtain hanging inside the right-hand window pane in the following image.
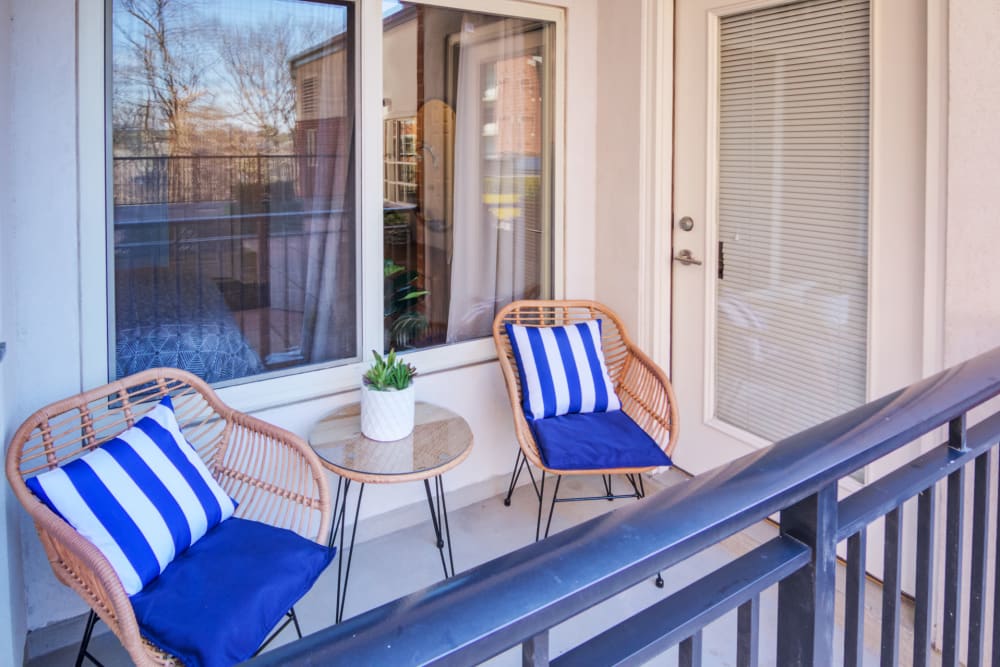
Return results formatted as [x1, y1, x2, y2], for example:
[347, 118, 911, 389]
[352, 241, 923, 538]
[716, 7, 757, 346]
[447, 21, 538, 343]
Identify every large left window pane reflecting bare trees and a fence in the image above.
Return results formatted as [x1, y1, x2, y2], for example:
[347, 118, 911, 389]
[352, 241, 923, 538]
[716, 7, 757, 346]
[109, 0, 359, 382]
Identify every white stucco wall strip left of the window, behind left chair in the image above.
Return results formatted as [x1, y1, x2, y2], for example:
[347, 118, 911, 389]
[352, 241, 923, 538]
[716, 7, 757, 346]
[4, 0, 90, 629]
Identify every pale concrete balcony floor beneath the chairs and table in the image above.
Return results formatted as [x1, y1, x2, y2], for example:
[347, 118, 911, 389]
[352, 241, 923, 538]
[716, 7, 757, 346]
[27, 471, 912, 667]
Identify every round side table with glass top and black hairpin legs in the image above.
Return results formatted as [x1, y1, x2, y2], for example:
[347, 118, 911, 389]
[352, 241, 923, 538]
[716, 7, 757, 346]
[309, 401, 472, 623]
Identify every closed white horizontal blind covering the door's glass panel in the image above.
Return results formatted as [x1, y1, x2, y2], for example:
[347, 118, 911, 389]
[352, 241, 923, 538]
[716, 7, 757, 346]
[715, 0, 871, 440]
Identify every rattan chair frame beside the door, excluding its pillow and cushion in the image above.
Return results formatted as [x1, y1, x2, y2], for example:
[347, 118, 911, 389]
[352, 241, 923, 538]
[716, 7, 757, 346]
[493, 301, 678, 540]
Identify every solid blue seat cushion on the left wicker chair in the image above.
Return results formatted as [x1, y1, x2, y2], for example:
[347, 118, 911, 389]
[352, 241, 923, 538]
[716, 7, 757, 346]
[132, 518, 336, 667]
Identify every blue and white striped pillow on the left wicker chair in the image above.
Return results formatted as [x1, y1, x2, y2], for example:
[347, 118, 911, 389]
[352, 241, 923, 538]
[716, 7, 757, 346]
[26, 396, 236, 595]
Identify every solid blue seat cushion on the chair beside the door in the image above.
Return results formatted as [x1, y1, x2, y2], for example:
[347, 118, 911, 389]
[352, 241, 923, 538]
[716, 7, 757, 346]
[528, 410, 671, 470]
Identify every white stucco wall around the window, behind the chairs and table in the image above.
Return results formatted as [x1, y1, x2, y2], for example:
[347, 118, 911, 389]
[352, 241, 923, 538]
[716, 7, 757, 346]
[0, 0, 597, 636]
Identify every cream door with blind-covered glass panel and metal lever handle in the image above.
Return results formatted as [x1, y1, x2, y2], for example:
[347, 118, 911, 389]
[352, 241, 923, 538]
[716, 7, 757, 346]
[671, 0, 884, 473]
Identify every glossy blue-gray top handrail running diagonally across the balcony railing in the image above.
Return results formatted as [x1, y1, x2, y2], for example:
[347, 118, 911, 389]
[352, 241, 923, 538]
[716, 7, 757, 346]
[254, 348, 1000, 665]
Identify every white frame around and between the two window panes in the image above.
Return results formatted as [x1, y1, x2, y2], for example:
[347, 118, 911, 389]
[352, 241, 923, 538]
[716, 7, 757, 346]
[77, 0, 568, 412]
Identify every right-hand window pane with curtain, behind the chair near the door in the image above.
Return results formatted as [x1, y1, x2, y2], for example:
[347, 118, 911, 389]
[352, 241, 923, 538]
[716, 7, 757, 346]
[382, 1, 553, 349]
